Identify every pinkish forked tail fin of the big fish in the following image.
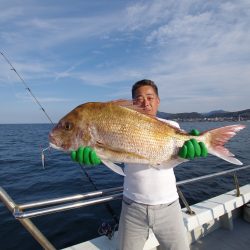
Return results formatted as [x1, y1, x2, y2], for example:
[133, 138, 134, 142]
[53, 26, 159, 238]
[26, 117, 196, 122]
[207, 124, 246, 165]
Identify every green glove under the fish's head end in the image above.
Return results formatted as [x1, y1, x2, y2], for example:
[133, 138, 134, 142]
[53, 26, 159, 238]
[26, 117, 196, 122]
[71, 147, 101, 166]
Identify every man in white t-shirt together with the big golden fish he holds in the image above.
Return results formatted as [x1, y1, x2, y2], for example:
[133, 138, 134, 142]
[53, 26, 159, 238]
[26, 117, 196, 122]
[50, 80, 244, 250]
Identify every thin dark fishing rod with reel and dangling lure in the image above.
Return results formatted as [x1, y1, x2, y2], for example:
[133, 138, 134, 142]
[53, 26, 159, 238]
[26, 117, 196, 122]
[0, 51, 119, 239]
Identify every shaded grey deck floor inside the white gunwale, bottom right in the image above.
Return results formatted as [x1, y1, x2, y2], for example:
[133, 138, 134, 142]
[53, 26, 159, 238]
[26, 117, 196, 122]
[190, 218, 250, 250]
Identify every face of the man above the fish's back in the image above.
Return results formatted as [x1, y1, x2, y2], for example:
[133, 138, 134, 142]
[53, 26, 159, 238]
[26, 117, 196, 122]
[133, 86, 160, 116]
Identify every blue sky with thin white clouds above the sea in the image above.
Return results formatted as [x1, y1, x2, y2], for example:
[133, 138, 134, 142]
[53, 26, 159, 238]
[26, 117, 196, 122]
[0, 0, 250, 123]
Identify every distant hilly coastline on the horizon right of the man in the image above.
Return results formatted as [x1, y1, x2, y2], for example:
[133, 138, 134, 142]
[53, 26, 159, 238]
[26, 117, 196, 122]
[157, 109, 250, 121]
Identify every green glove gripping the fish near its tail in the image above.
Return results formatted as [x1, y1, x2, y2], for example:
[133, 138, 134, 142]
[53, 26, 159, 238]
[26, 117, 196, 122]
[178, 129, 207, 160]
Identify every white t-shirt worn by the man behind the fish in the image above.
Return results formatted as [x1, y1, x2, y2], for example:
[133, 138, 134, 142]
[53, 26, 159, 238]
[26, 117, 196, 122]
[123, 118, 180, 205]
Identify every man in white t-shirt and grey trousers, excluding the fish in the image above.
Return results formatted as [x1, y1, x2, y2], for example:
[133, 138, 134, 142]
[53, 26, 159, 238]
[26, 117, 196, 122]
[72, 80, 206, 250]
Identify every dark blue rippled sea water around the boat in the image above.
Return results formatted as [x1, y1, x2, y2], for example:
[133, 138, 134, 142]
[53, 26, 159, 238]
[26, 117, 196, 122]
[0, 122, 250, 250]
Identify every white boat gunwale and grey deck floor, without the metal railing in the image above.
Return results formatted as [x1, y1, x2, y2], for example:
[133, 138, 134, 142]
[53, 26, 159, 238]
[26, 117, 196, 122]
[63, 185, 250, 250]
